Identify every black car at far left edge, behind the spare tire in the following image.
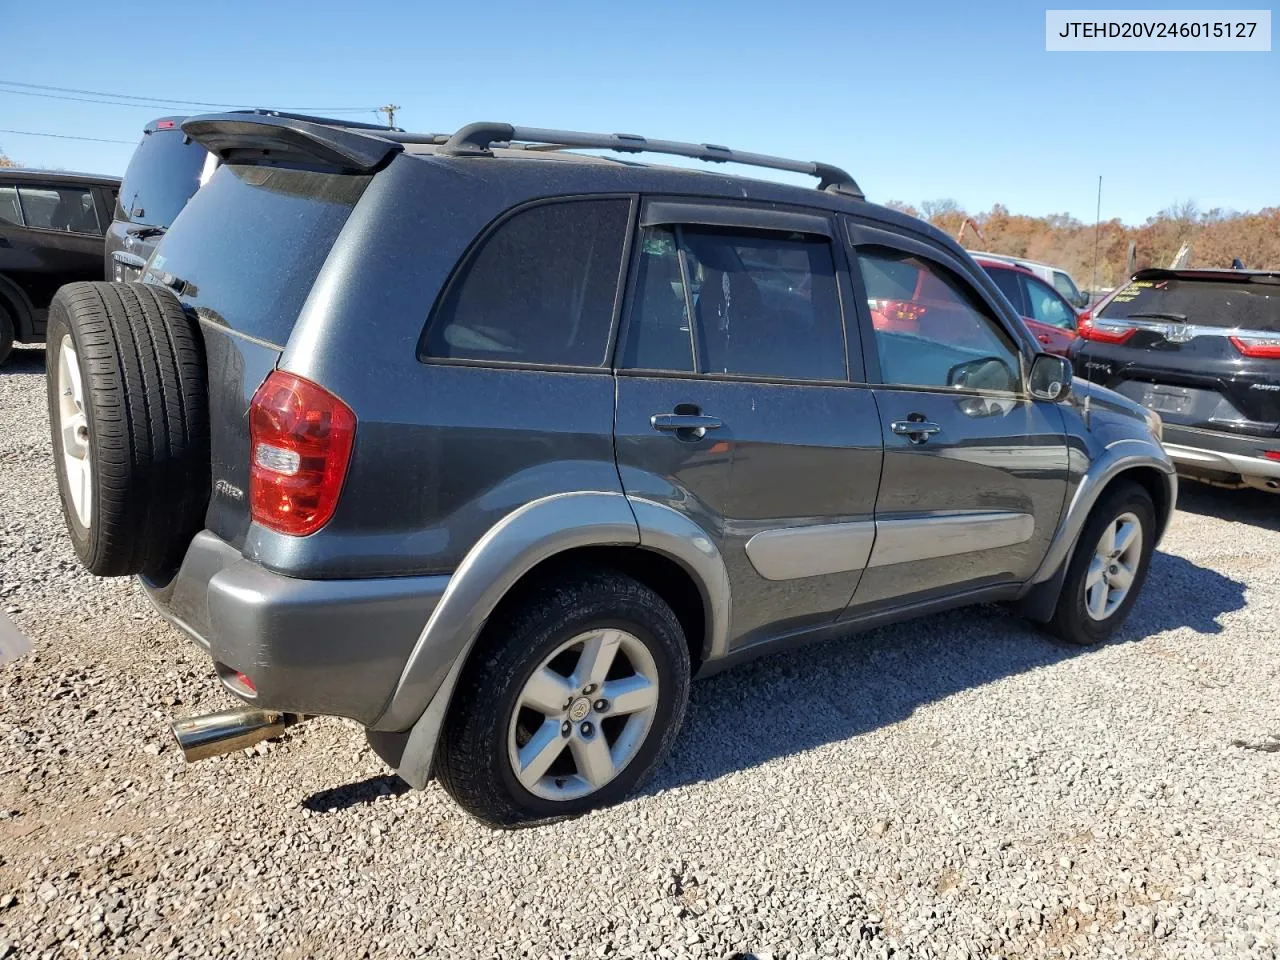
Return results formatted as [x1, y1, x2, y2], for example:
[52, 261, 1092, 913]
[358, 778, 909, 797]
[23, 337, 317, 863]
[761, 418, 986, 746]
[0, 168, 120, 364]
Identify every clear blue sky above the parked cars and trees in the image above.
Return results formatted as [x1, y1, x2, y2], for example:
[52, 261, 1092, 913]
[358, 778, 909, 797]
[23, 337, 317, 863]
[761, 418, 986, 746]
[0, 0, 1280, 223]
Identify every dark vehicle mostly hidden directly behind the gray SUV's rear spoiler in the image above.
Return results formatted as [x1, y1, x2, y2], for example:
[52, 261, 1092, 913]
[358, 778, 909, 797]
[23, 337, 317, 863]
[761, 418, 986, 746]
[106, 110, 399, 280]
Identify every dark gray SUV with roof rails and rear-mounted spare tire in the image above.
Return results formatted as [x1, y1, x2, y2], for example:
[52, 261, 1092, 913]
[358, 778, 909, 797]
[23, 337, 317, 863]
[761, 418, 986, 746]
[49, 115, 1176, 826]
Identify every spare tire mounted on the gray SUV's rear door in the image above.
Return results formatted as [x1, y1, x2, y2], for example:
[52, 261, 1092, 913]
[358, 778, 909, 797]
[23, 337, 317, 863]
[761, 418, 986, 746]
[45, 282, 210, 576]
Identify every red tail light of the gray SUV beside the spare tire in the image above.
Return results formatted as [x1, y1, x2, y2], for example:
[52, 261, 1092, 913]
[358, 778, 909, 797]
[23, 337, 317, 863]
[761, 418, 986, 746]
[248, 370, 356, 536]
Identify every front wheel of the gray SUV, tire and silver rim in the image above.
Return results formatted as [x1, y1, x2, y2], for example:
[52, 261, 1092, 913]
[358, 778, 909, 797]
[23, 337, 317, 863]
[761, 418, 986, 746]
[1048, 483, 1156, 646]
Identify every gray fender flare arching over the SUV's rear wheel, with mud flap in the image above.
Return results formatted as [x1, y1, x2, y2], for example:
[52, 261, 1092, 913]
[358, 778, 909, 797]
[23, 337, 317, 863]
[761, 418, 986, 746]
[369, 492, 730, 790]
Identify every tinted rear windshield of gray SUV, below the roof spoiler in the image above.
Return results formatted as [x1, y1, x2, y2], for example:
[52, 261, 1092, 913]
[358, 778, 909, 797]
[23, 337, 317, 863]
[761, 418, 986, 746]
[143, 165, 370, 346]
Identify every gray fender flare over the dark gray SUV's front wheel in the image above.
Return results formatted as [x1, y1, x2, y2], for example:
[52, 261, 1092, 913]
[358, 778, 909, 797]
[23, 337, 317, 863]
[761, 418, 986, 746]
[1018, 438, 1178, 621]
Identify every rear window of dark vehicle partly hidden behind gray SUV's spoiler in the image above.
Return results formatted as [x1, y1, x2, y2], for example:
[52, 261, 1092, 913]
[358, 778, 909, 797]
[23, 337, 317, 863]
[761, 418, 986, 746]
[115, 129, 209, 227]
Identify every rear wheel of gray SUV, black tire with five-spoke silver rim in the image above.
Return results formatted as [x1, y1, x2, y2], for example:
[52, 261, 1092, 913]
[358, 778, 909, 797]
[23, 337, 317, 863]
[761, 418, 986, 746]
[436, 570, 690, 827]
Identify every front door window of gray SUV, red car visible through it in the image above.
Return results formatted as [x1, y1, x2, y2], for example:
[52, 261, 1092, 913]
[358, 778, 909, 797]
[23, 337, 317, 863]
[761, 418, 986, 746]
[858, 248, 1021, 393]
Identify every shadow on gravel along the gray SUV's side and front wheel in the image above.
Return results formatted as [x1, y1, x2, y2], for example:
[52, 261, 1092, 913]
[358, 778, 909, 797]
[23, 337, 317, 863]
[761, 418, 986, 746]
[645, 553, 1244, 794]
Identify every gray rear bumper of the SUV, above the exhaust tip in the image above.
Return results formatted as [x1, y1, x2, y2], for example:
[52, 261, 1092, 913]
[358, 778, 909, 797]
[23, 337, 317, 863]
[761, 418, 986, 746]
[142, 530, 449, 724]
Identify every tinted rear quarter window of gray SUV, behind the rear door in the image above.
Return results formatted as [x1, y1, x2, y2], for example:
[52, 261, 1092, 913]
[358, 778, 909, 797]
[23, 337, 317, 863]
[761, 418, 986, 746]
[424, 200, 631, 367]
